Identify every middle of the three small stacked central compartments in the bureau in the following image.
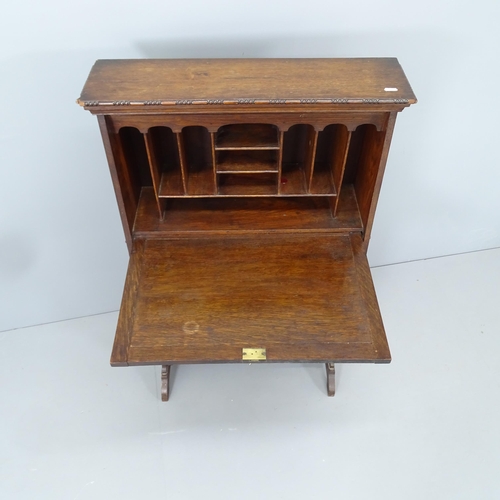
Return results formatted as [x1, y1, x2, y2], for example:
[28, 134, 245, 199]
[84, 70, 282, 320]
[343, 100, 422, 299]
[216, 150, 278, 173]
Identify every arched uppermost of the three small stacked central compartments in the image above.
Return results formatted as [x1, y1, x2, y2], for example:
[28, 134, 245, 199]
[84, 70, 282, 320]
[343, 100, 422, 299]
[215, 123, 280, 151]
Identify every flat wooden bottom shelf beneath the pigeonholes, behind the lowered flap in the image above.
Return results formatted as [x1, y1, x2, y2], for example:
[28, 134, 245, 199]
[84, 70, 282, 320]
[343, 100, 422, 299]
[134, 186, 363, 238]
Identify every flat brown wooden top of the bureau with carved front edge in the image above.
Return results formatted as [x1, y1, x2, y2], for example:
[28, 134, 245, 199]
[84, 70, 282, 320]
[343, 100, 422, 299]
[78, 58, 416, 106]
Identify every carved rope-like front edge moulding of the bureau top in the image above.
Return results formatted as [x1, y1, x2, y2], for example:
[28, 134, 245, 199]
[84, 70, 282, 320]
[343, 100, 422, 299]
[76, 97, 417, 108]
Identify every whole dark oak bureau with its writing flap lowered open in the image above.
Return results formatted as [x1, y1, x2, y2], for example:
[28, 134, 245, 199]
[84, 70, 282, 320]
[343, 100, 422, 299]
[78, 59, 416, 400]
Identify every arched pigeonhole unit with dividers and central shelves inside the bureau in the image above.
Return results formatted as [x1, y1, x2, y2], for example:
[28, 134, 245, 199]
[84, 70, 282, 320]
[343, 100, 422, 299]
[110, 116, 385, 223]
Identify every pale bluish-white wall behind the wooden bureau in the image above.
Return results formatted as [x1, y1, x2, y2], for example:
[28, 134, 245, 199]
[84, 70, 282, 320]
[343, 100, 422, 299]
[0, 0, 500, 331]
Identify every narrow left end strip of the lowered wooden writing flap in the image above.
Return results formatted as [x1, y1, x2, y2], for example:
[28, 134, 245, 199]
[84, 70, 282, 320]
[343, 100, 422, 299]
[111, 240, 145, 366]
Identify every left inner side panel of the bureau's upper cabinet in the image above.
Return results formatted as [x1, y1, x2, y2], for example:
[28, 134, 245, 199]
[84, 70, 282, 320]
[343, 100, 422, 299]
[97, 115, 134, 253]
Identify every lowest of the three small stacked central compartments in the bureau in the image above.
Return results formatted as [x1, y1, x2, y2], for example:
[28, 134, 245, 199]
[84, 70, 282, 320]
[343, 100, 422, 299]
[218, 173, 278, 196]
